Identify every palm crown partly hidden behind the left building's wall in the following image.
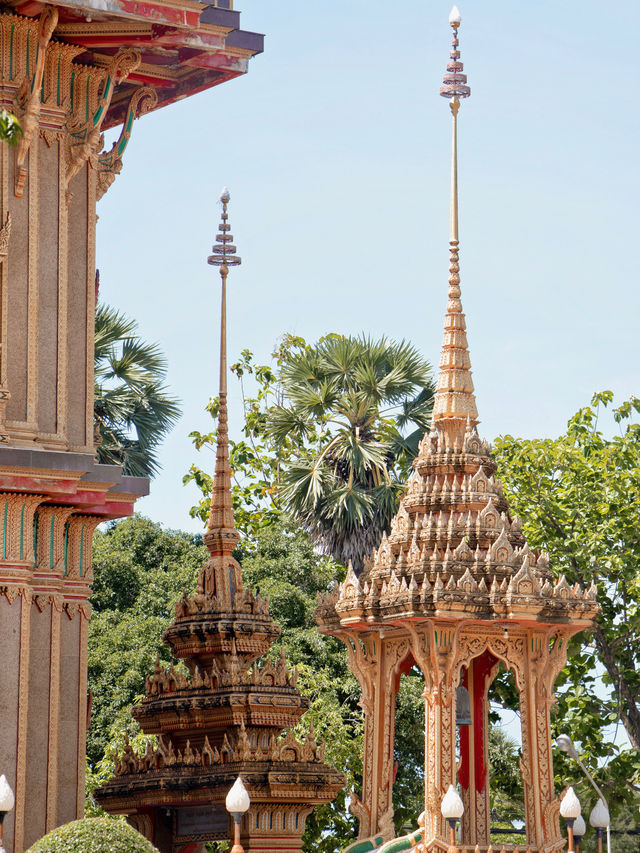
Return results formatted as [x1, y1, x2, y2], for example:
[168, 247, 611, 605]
[94, 305, 181, 477]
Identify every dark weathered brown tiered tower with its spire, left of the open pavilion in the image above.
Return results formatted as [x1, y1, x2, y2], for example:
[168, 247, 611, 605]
[95, 191, 344, 853]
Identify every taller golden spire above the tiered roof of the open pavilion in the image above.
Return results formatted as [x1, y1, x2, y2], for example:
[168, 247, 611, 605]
[433, 6, 478, 439]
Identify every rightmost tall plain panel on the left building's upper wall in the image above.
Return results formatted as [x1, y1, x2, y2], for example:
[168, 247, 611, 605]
[67, 167, 93, 449]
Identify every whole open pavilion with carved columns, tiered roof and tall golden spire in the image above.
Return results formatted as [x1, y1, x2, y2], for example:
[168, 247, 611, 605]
[316, 7, 598, 851]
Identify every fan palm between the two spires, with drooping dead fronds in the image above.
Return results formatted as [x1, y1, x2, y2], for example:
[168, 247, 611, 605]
[269, 335, 434, 572]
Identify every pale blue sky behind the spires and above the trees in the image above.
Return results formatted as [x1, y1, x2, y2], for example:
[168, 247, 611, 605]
[98, 0, 640, 530]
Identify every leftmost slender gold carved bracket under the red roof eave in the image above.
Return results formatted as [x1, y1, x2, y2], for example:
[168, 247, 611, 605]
[14, 6, 58, 198]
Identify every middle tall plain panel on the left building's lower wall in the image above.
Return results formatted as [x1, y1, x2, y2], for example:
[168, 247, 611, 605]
[24, 604, 52, 849]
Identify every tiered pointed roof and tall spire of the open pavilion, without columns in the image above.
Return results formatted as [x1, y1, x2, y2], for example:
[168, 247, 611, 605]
[316, 6, 596, 631]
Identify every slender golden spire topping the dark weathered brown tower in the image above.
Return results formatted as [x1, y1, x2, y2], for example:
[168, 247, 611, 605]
[204, 187, 242, 555]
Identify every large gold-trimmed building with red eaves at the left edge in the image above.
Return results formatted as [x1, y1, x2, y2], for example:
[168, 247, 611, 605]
[0, 0, 262, 853]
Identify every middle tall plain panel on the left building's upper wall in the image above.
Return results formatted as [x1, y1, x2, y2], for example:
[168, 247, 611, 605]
[37, 139, 59, 434]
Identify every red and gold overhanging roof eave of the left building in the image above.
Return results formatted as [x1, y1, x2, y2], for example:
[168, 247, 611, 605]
[8, 0, 264, 129]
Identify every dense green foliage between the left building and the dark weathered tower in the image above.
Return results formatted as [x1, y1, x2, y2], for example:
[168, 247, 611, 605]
[87, 516, 208, 764]
